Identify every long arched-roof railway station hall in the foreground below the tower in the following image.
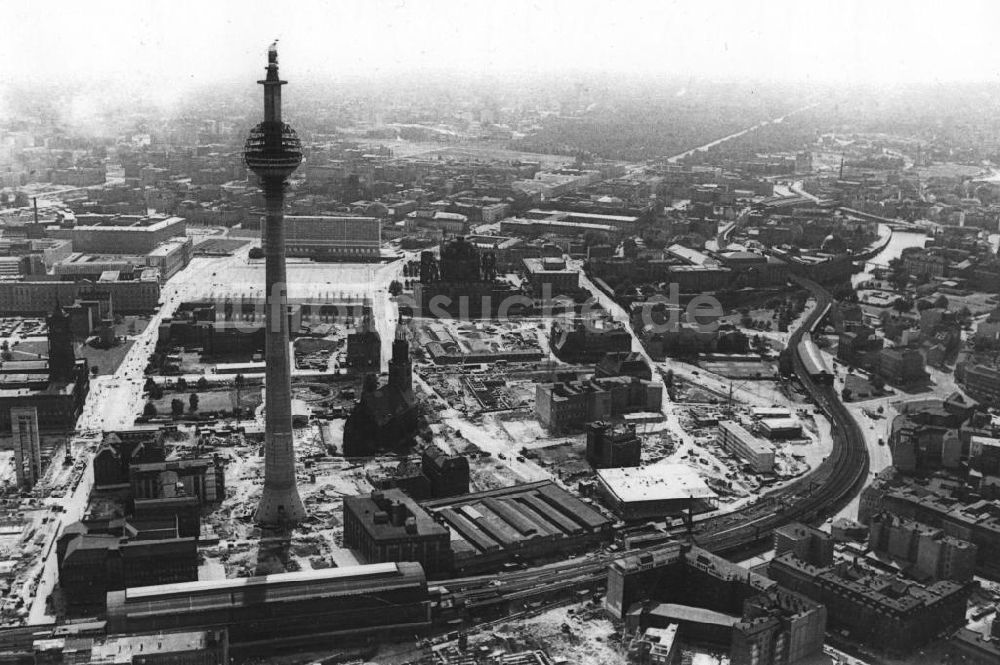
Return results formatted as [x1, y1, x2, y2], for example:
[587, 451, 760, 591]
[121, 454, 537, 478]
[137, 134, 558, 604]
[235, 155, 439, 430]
[107, 562, 431, 649]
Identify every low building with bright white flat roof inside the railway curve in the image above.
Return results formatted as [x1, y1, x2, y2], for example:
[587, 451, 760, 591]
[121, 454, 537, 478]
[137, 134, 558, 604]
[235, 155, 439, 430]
[597, 464, 717, 522]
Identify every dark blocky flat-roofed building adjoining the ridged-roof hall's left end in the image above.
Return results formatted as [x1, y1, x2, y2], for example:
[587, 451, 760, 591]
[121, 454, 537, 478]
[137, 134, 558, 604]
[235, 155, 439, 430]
[344, 489, 451, 576]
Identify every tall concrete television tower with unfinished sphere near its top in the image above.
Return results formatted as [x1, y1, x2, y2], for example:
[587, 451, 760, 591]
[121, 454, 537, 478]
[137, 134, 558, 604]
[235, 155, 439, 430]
[243, 42, 306, 526]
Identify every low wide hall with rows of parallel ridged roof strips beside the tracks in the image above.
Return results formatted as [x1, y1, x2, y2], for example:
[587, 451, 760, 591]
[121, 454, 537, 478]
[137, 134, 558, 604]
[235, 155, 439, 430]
[422, 481, 611, 574]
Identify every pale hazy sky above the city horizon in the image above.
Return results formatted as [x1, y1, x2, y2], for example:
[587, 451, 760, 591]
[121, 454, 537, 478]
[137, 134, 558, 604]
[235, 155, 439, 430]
[0, 0, 1000, 88]
